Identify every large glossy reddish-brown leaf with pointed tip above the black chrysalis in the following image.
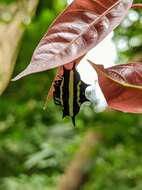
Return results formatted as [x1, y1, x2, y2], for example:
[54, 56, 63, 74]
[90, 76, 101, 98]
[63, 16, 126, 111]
[13, 0, 132, 80]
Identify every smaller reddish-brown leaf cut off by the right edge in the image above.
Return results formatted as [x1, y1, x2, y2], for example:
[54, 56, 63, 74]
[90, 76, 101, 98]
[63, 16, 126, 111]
[89, 61, 142, 113]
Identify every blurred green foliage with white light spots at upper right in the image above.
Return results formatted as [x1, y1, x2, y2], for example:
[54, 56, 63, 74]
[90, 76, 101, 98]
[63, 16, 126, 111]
[114, 0, 142, 63]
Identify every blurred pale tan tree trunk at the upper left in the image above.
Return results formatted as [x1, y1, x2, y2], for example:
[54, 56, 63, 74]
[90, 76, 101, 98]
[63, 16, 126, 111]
[0, 0, 38, 95]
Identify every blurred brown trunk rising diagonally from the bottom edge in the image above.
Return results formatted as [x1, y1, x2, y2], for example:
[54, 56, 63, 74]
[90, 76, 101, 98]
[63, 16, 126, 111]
[57, 130, 100, 190]
